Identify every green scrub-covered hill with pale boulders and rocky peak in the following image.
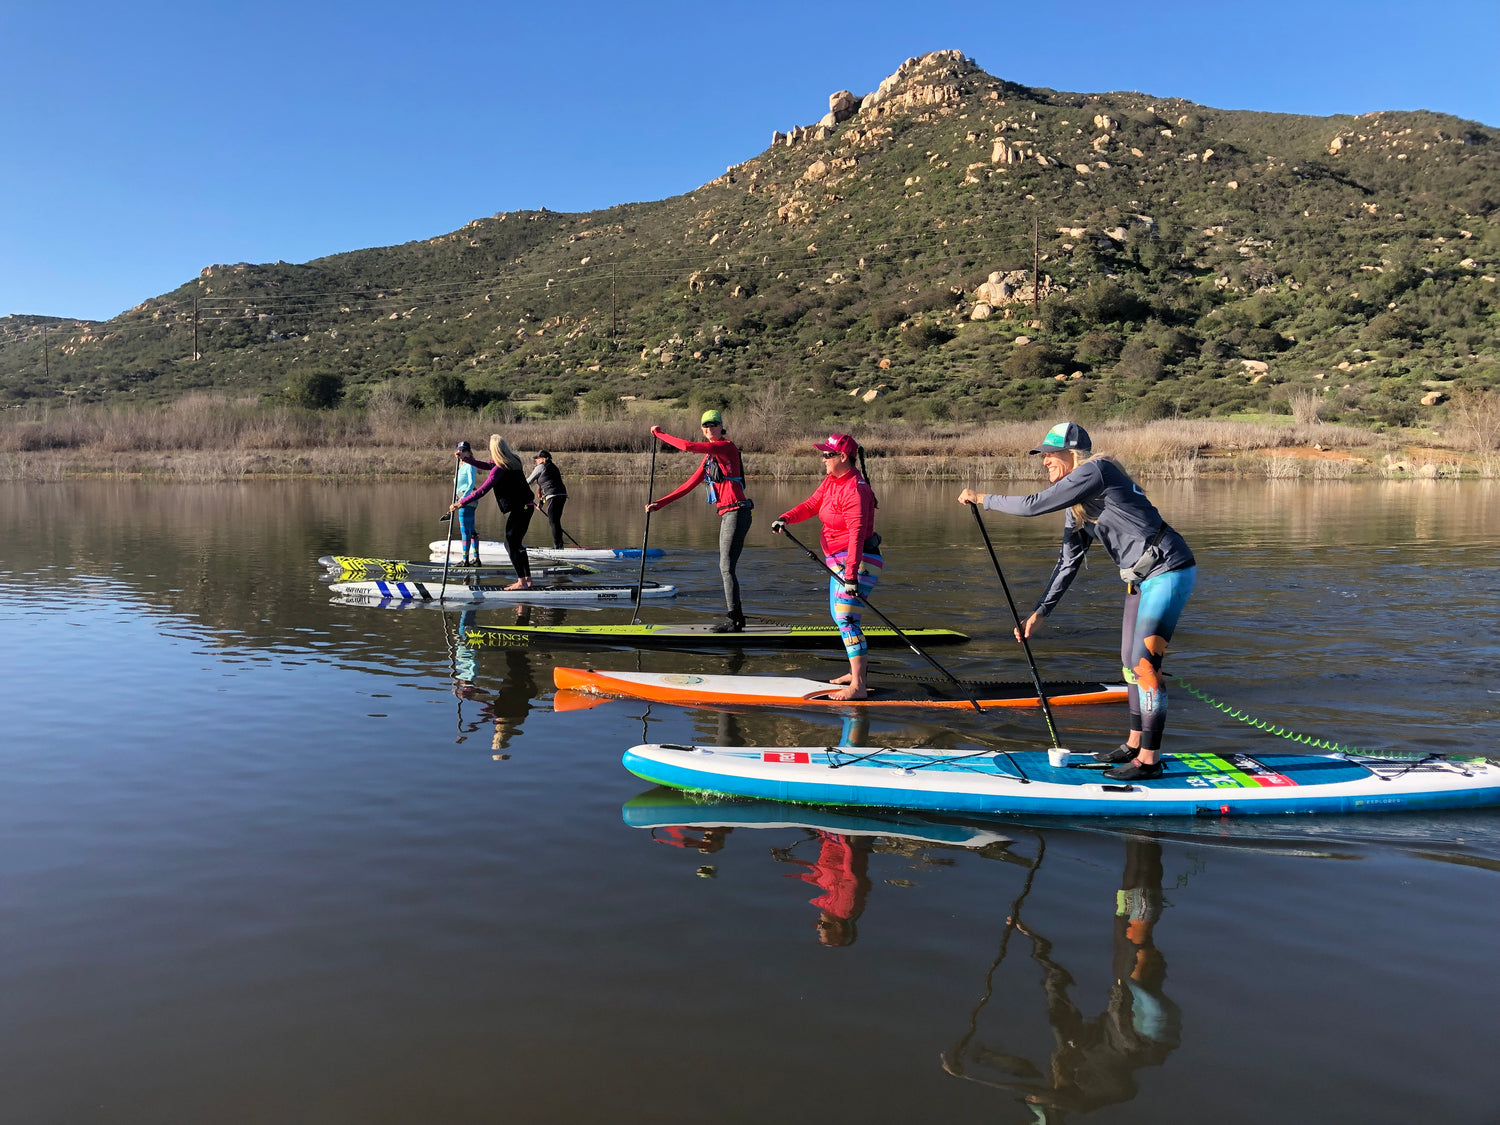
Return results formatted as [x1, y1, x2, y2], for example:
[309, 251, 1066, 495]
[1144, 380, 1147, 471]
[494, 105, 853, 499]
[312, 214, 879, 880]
[0, 51, 1500, 426]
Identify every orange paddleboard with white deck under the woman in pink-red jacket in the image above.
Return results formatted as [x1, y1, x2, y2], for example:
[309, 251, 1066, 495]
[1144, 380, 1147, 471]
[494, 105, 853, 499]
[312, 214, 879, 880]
[552, 668, 1128, 711]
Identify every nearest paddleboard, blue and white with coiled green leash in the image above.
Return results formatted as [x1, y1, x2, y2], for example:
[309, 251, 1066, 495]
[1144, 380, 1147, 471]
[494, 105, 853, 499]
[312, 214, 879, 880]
[624, 744, 1500, 816]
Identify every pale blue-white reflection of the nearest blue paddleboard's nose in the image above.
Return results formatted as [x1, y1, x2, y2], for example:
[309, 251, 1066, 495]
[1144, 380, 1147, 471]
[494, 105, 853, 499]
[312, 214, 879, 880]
[620, 786, 1011, 848]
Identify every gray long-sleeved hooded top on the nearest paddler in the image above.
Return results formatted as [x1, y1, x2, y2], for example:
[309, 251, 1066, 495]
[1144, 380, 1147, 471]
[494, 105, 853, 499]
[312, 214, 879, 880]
[984, 458, 1196, 617]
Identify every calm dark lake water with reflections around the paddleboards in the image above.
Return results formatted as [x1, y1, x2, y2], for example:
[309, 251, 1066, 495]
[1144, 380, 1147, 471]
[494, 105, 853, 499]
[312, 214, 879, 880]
[0, 477, 1500, 1125]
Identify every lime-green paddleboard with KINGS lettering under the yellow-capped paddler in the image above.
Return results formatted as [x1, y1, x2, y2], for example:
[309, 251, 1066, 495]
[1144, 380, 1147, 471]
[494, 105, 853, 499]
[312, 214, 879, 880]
[468, 623, 969, 648]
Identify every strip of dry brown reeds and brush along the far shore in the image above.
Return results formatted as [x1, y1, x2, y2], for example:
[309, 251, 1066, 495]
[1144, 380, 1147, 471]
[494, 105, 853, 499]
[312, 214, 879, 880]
[0, 393, 1500, 483]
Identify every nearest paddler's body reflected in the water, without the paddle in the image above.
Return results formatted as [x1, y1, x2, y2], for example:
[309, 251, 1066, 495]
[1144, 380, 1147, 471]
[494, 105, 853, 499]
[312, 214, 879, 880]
[1016, 839, 1182, 1121]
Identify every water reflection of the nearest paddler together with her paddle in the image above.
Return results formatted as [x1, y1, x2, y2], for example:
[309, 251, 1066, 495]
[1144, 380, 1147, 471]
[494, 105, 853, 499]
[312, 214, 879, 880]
[944, 837, 1182, 1122]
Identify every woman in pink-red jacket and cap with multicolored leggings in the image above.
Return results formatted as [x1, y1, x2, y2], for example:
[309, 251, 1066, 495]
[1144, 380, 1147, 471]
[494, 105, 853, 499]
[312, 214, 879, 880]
[771, 434, 885, 699]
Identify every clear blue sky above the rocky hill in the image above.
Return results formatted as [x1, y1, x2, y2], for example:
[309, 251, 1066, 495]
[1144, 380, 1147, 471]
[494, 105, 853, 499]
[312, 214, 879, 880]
[0, 0, 1500, 318]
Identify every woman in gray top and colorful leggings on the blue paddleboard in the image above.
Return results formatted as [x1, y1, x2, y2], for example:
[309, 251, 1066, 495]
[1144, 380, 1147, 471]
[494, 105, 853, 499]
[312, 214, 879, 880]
[959, 422, 1199, 782]
